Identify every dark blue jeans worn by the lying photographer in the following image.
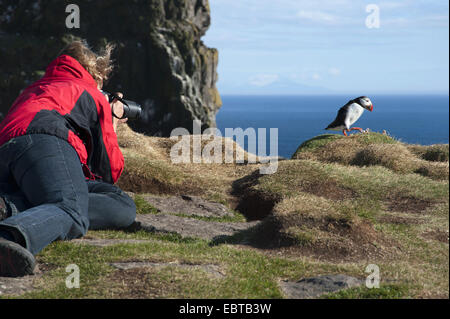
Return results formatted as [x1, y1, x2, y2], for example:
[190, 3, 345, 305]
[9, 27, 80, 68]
[0, 134, 136, 254]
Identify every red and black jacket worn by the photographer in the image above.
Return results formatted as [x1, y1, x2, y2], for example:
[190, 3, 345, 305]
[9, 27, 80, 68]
[0, 55, 124, 183]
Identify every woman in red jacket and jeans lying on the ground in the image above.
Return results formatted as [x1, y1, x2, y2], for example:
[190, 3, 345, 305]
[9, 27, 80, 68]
[0, 41, 136, 277]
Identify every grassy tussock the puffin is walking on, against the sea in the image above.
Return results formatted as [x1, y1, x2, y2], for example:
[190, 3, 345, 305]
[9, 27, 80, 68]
[293, 133, 449, 180]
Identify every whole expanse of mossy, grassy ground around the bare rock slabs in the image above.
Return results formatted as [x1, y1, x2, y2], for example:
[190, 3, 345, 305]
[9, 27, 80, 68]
[5, 127, 449, 298]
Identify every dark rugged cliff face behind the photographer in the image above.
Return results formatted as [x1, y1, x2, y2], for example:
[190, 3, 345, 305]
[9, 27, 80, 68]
[0, 0, 221, 136]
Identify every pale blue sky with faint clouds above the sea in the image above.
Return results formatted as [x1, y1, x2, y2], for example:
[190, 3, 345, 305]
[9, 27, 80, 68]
[203, 0, 449, 95]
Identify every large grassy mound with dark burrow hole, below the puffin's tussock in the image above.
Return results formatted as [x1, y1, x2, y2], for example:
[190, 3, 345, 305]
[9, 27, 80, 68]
[230, 160, 448, 261]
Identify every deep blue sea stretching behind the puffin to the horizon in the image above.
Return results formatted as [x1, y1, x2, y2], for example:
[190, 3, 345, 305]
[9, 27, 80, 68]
[216, 95, 449, 158]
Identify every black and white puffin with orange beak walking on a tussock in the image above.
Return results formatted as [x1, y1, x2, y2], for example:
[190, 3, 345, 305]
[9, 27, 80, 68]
[325, 96, 373, 136]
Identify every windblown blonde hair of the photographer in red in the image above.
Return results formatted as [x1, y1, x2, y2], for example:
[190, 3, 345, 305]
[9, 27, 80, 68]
[59, 40, 115, 85]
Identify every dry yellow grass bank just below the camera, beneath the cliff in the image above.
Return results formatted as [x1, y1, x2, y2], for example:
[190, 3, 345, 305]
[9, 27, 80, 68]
[117, 125, 260, 198]
